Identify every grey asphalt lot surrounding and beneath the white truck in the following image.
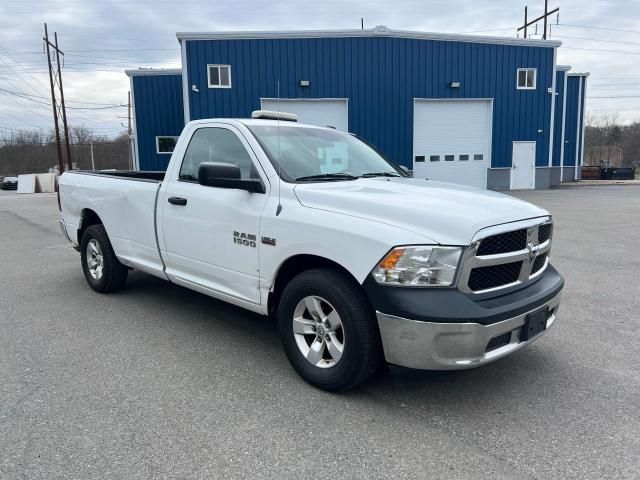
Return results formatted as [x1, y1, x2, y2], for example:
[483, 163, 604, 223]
[0, 185, 640, 480]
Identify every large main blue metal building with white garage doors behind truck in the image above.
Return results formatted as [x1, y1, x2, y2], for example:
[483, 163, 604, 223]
[127, 27, 584, 190]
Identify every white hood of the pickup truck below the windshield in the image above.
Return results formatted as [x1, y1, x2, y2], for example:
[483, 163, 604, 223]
[294, 177, 549, 245]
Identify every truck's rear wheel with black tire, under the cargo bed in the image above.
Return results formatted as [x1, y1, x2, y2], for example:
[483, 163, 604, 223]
[80, 225, 129, 293]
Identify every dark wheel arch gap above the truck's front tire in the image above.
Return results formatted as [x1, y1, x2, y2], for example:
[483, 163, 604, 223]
[267, 254, 368, 317]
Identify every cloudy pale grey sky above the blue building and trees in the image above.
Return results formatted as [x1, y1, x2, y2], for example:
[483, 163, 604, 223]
[0, 0, 640, 138]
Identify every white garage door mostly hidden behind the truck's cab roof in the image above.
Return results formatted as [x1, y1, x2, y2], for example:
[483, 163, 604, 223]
[262, 98, 349, 132]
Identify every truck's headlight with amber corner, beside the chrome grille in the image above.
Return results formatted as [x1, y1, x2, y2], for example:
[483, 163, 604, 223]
[372, 245, 462, 287]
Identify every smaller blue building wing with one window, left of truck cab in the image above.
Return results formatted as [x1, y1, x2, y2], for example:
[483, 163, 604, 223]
[126, 69, 185, 170]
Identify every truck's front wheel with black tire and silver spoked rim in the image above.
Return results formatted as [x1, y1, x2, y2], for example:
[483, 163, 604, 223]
[278, 268, 382, 392]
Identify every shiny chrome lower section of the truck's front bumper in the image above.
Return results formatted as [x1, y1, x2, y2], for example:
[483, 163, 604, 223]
[376, 293, 561, 370]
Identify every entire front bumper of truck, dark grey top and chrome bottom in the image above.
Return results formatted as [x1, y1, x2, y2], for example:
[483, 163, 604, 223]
[363, 265, 564, 370]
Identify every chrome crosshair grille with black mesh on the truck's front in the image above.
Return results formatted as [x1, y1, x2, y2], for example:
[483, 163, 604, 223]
[458, 218, 553, 293]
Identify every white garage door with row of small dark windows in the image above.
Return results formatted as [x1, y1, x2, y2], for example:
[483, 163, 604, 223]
[413, 99, 492, 188]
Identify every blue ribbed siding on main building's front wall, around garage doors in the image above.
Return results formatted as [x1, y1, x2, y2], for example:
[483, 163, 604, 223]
[187, 37, 553, 167]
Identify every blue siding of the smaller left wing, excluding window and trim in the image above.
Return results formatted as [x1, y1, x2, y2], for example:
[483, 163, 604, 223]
[133, 74, 184, 170]
